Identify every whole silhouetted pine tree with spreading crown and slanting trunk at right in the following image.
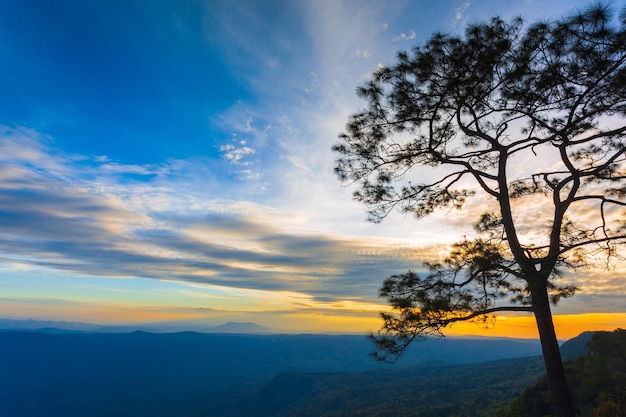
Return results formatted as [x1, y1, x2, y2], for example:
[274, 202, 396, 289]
[333, 5, 626, 417]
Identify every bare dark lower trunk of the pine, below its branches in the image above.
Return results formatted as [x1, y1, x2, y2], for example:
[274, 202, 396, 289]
[531, 286, 575, 417]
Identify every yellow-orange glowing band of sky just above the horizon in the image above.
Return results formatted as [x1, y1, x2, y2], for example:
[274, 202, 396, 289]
[0, 300, 626, 340]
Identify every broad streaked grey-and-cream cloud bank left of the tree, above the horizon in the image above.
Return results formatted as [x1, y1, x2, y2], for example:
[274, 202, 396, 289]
[0, 125, 428, 300]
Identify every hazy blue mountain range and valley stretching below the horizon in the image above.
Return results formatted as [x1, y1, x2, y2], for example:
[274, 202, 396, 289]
[0, 319, 590, 417]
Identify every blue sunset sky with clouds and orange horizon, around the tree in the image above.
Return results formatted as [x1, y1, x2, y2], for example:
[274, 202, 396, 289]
[0, 0, 626, 337]
